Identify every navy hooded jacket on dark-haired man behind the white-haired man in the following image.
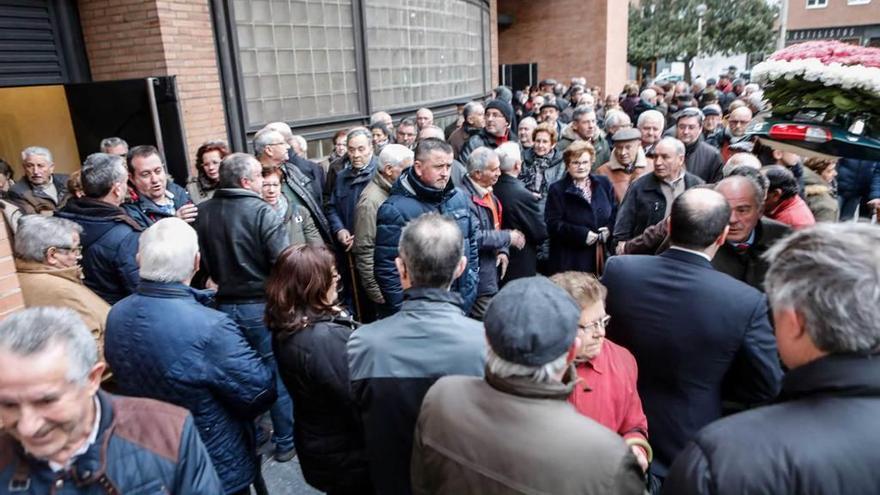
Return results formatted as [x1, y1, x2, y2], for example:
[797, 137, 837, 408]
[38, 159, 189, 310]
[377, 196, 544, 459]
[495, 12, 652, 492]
[56, 198, 143, 305]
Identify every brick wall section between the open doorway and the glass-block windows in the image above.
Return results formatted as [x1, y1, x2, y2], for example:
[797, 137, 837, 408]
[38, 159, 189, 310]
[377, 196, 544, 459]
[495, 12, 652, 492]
[79, 0, 227, 174]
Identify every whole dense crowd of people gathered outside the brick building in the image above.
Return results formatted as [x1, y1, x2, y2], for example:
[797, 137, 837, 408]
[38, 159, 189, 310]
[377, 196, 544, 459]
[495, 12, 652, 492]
[0, 74, 880, 495]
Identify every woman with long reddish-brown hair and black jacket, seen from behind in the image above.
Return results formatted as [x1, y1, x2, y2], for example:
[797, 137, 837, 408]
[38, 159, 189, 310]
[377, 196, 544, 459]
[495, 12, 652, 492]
[266, 246, 372, 495]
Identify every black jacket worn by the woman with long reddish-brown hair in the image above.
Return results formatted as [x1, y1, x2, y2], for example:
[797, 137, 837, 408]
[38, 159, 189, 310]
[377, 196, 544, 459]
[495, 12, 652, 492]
[272, 316, 372, 493]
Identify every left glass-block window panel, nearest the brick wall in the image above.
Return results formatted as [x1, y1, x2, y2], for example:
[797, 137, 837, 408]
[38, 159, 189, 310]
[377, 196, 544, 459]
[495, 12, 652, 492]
[233, 0, 362, 128]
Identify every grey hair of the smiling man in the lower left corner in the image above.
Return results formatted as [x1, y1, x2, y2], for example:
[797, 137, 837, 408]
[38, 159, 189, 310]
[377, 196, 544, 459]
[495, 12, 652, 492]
[0, 307, 98, 384]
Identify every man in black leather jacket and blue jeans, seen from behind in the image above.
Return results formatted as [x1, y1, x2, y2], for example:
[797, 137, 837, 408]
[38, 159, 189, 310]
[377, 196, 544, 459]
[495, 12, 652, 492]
[196, 153, 295, 462]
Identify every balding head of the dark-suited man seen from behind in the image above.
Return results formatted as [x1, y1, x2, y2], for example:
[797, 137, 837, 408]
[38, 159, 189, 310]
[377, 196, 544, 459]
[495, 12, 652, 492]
[669, 188, 730, 256]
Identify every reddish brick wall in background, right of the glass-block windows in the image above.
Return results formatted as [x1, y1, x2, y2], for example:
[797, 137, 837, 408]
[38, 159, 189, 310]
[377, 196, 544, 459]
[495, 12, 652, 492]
[498, 0, 627, 95]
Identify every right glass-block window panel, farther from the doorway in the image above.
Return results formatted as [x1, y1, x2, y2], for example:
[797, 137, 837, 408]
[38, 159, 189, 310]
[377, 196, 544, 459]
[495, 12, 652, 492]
[365, 0, 491, 110]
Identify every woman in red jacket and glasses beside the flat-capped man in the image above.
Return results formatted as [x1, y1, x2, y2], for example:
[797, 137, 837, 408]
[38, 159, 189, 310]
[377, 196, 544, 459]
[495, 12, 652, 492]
[550, 272, 652, 470]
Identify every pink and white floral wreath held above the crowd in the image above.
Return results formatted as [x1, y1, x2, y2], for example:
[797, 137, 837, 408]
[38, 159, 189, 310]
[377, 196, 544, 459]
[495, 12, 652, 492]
[752, 41, 880, 135]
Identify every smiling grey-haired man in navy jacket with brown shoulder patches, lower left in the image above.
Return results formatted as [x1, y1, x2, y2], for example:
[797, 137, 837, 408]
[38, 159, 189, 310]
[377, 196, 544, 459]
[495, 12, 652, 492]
[0, 308, 223, 495]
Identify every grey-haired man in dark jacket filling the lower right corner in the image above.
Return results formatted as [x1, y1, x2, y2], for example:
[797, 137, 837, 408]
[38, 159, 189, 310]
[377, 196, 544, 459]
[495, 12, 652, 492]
[665, 223, 880, 495]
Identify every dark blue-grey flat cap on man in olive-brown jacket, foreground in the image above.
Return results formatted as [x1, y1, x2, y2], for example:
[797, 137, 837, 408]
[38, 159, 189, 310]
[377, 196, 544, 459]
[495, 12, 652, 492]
[483, 276, 581, 366]
